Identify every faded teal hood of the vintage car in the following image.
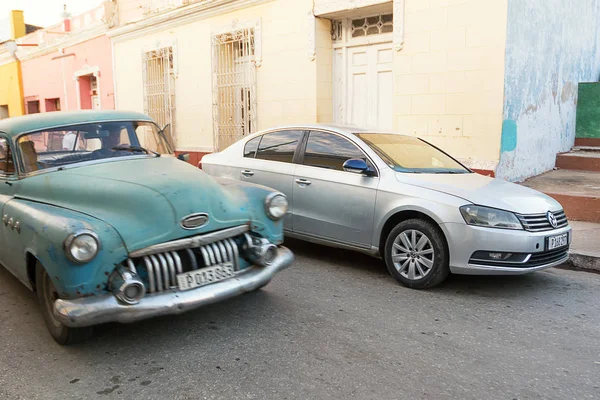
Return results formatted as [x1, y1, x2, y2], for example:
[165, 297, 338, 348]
[15, 157, 252, 251]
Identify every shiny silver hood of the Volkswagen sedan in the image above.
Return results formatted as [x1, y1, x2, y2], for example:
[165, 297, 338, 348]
[396, 172, 562, 214]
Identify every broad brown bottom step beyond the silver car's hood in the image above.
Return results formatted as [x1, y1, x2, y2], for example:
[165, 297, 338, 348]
[522, 169, 600, 223]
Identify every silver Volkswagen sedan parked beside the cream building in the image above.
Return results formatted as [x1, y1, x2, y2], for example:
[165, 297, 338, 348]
[201, 125, 571, 288]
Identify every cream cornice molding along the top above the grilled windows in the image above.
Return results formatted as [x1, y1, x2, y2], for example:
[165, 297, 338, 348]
[107, 0, 274, 42]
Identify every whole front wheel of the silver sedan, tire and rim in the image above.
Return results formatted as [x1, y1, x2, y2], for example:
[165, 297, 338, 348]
[384, 219, 450, 289]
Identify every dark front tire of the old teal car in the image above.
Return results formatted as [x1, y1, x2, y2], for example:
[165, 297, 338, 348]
[35, 262, 92, 345]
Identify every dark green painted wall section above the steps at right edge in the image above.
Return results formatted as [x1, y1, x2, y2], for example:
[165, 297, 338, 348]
[575, 82, 600, 139]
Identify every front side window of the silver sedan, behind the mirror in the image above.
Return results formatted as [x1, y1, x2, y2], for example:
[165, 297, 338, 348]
[303, 131, 369, 171]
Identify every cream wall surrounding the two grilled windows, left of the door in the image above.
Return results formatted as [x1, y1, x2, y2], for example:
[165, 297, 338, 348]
[113, 0, 317, 151]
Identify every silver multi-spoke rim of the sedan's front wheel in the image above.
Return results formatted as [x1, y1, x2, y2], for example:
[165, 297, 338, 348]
[392, 229, 435, 280]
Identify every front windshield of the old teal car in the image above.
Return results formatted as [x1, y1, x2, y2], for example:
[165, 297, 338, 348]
[17, 121, 172, 173]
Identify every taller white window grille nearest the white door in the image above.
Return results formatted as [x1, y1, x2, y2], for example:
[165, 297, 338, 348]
[212, 28, 256, 151]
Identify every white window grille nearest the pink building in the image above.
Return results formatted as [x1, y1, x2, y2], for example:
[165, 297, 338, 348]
[142, 46, 176, 149]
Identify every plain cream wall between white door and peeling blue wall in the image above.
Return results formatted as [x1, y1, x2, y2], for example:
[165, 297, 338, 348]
[394, 0, 508, 170]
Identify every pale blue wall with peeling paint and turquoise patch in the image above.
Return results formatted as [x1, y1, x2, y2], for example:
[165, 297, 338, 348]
[496, 0, 600, 181]
